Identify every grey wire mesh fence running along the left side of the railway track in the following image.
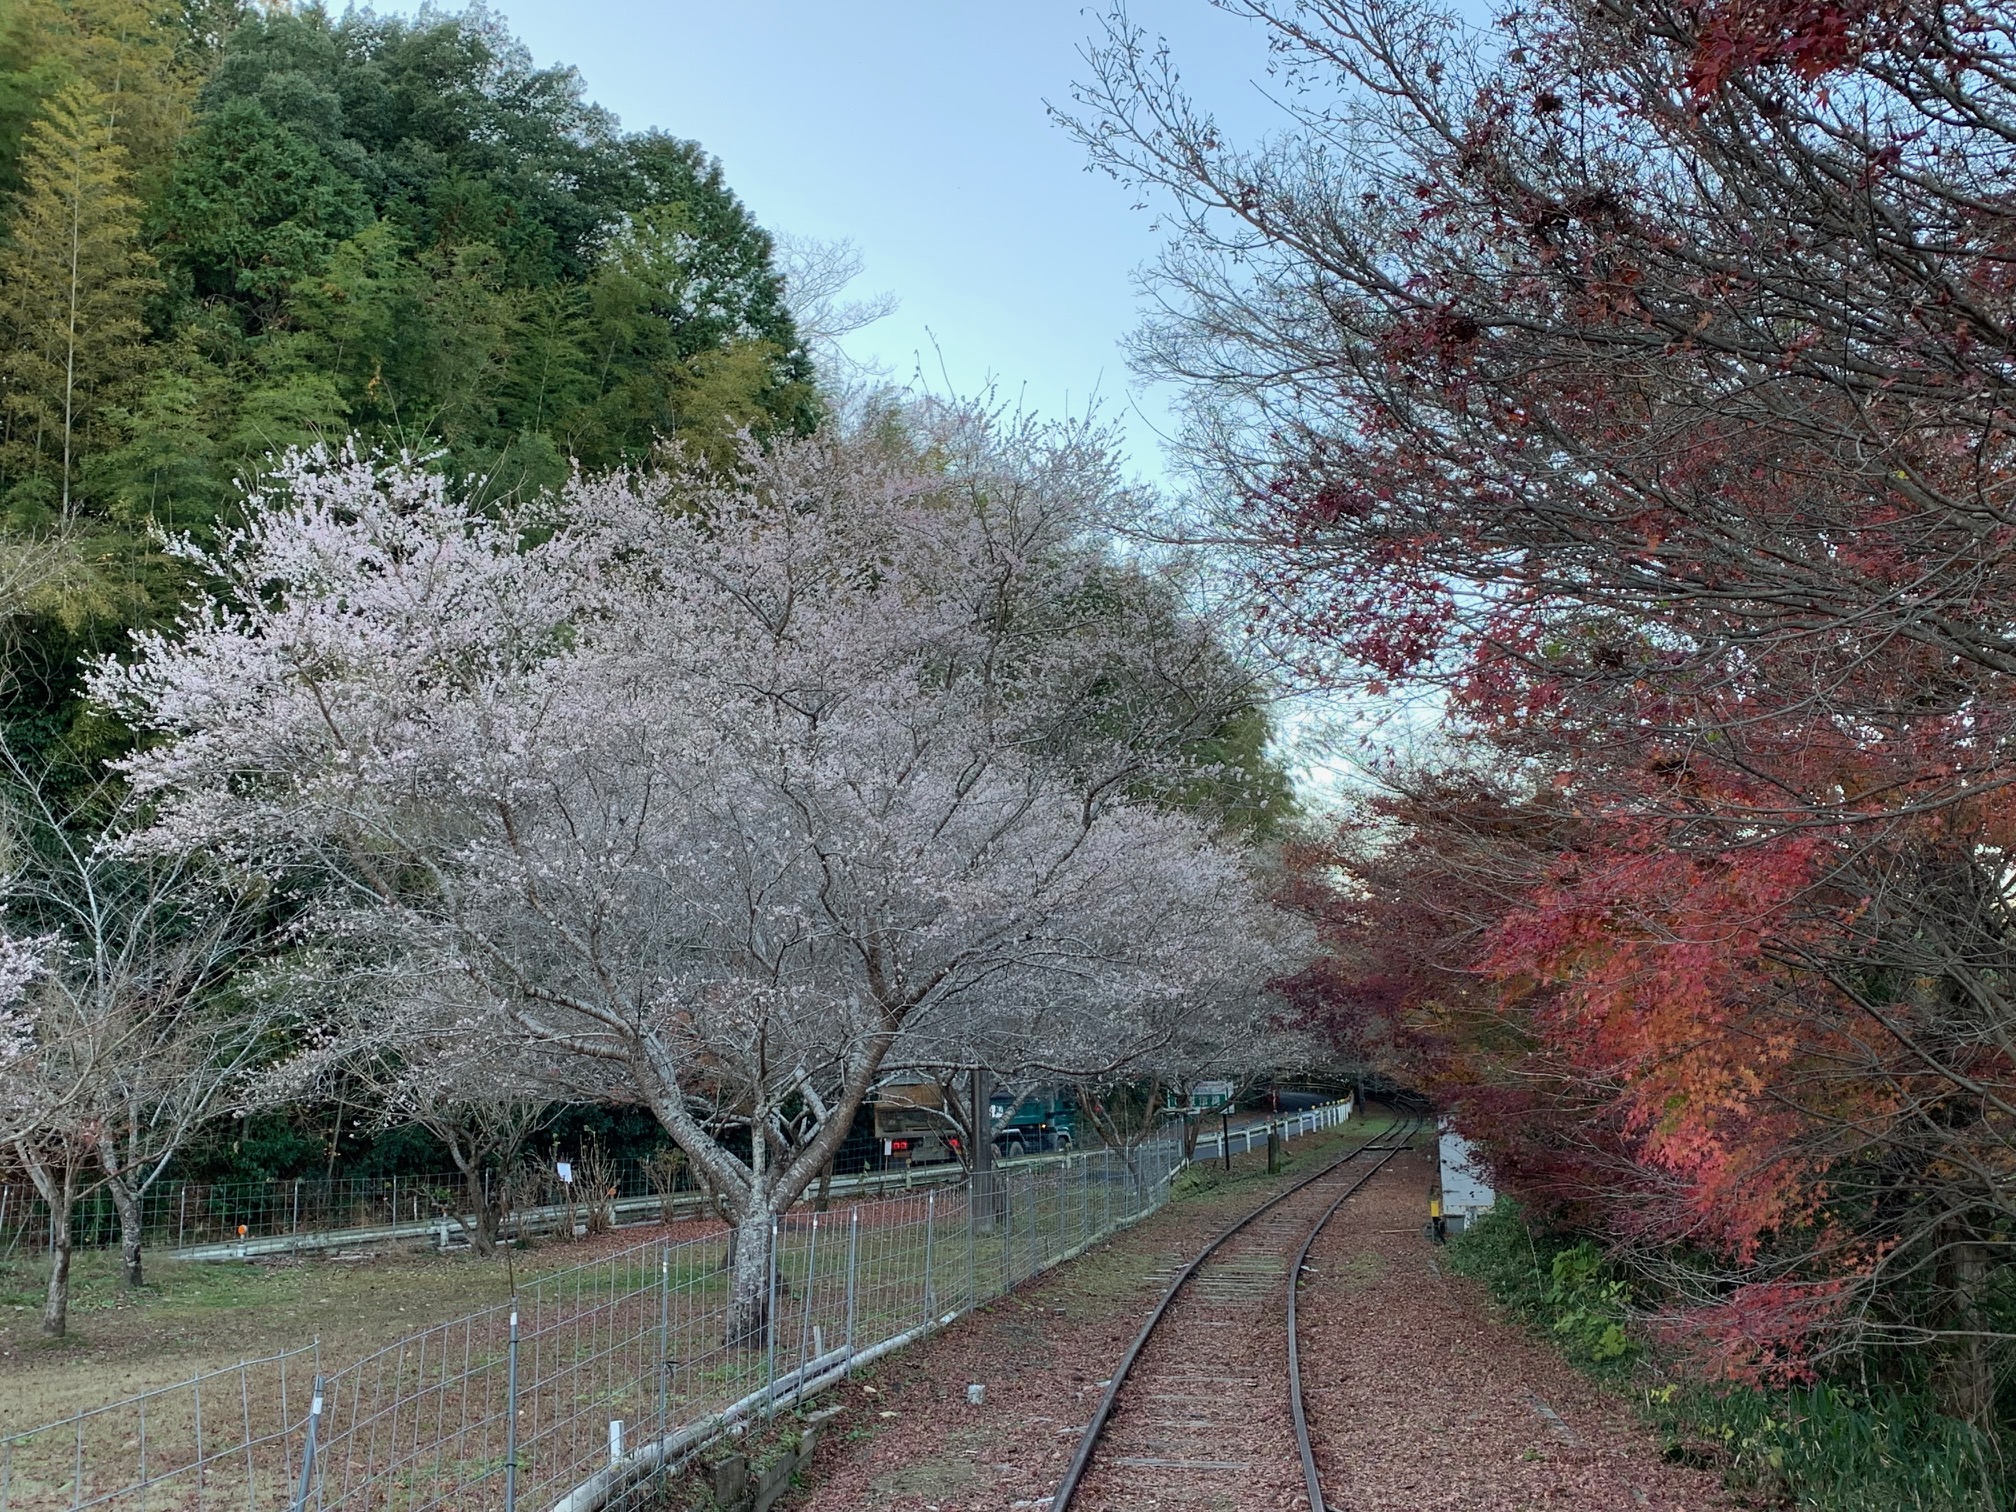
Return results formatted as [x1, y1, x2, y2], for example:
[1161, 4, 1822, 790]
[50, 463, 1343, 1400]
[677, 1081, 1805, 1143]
[0, 1105, 1349, 1512]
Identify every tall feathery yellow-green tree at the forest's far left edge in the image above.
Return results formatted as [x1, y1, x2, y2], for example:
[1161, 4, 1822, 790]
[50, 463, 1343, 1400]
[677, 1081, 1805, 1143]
[0, 81, 153, 524]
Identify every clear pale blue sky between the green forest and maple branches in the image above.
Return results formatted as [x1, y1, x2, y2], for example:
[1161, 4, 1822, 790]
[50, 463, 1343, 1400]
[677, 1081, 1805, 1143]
[459, 0, 1270, 476]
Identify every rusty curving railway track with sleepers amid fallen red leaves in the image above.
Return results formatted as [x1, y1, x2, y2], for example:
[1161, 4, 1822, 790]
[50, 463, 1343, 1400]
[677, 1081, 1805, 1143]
[1050, 1119, 1425, 1512]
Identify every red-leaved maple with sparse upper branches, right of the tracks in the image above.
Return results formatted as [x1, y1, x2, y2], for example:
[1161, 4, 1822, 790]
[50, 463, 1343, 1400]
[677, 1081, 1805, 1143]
[1077, 0, 2016, 1419]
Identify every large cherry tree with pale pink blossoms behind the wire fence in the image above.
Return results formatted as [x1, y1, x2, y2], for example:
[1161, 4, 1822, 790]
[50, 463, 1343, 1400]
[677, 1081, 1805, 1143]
[93, 413, 1270, 1343]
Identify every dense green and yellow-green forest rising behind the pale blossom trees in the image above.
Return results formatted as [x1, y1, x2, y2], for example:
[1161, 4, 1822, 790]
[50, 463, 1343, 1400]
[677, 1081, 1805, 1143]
[0, 0, 816, 760]
